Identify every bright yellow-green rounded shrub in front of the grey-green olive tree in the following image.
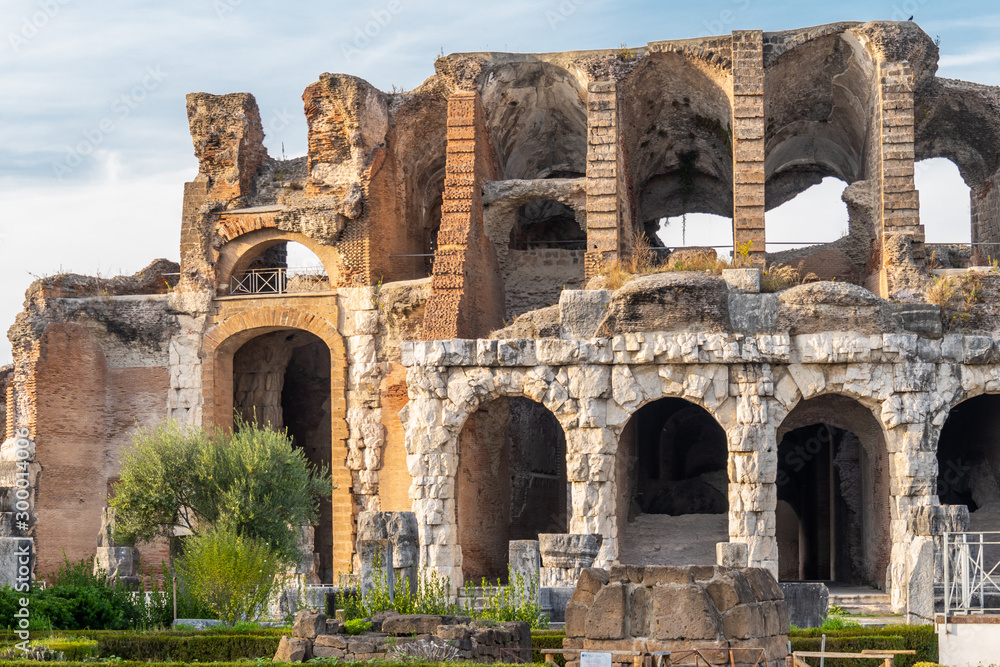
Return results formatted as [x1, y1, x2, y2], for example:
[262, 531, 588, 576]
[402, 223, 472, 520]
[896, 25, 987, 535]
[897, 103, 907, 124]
[176, 527, 283, 628]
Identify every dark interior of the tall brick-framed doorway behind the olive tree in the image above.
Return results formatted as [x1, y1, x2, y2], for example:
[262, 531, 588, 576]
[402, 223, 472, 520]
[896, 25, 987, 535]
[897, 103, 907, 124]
[232, 329, 334, 583]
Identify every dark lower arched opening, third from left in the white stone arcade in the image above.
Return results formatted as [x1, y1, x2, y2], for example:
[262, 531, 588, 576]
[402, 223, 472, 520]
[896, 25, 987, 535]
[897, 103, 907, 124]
[776, 394, 891, 588]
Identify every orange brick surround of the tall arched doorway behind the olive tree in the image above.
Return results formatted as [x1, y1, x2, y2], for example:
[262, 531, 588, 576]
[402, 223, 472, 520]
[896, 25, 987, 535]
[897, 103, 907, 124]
[201, 305, 355, 573]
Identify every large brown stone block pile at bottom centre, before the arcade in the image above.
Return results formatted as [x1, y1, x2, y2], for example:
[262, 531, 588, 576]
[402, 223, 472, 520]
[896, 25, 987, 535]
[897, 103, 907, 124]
[563, 565, 789, 667]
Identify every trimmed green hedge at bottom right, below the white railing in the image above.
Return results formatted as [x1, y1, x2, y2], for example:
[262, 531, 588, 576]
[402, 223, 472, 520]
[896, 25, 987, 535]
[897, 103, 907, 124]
[788, 625, 938, 667]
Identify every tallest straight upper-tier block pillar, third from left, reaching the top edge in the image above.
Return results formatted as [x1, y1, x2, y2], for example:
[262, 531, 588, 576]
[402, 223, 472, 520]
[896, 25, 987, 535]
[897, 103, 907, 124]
[733, 30, 765, 266]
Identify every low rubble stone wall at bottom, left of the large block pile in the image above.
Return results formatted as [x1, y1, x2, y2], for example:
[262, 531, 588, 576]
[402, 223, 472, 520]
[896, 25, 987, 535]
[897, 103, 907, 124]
[274, 610, 531, 662]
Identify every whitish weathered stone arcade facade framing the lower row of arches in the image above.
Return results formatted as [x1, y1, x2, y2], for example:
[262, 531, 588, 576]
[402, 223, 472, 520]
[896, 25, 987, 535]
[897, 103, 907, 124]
[401, 298, 1000, 616]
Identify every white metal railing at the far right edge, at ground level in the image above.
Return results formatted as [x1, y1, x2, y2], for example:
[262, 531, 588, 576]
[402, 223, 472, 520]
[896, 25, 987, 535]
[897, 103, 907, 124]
[942, 532, 1000, 618]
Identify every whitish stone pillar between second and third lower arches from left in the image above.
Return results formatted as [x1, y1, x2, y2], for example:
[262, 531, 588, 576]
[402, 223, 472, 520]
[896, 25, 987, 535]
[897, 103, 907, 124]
[727, 364, 778, 579]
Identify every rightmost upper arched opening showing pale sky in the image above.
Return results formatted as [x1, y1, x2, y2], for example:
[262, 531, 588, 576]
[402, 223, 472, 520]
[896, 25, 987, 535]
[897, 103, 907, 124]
[913, 157, 972, 269]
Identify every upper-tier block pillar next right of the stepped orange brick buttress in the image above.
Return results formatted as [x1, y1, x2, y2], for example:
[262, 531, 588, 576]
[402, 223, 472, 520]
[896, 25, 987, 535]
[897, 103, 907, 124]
[584, 81, 631, 278]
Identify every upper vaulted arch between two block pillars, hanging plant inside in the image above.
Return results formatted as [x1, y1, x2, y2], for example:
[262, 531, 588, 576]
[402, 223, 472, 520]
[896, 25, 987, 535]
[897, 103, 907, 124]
[619, 52, 733, 255]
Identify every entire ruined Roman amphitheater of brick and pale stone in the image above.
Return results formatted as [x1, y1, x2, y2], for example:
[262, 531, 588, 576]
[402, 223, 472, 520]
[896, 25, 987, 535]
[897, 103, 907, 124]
[0, 22, 1000, 618]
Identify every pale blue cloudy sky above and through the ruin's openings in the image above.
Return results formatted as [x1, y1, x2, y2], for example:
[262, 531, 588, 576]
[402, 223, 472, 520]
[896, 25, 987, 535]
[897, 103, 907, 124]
[0, 0, 1000, 365]
